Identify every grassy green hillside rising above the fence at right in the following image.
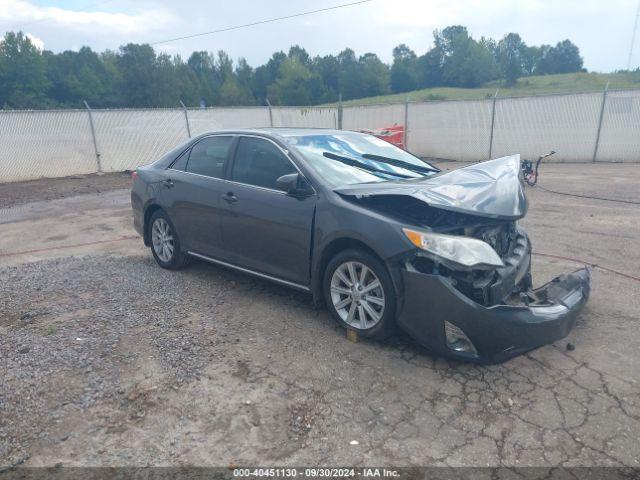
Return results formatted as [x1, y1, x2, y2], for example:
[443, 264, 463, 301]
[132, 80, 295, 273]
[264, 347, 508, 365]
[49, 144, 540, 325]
[336, 72, 640, 105]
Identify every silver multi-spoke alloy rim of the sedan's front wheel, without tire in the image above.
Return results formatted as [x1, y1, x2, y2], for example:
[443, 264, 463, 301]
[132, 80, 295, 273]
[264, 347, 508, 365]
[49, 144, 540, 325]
[331, 261, 385, 330]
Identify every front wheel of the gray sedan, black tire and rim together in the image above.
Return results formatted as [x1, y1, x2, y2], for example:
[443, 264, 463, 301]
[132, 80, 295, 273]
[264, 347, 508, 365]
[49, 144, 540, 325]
[323, 250, 396, 339]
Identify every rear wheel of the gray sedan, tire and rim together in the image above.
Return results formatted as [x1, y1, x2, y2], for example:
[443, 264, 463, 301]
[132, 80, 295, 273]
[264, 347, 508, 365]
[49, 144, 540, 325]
[147, 210, 191, 270]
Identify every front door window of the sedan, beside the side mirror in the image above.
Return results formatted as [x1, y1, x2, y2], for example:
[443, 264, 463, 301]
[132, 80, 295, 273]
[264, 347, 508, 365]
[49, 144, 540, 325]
[231, 137, 297, 190]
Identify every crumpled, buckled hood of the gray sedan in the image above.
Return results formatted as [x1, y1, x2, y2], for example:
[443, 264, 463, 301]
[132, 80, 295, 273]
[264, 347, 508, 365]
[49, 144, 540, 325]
[334, 155, 527, 220]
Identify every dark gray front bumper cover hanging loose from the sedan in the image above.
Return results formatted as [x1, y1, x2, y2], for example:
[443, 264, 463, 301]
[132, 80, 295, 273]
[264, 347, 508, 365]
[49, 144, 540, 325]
[398, 268, 591, 363]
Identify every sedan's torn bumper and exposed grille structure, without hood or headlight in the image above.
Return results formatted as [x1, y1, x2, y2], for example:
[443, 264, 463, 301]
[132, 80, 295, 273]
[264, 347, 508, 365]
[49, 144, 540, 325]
[397, 222, 590, 363]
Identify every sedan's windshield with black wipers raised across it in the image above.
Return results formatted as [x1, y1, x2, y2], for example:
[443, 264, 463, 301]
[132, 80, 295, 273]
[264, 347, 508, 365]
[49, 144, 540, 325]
[284, 132, 438, 187]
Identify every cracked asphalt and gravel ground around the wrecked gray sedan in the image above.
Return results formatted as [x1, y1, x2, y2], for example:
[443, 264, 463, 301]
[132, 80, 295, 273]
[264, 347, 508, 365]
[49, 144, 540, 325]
[0, 164, 640, 467]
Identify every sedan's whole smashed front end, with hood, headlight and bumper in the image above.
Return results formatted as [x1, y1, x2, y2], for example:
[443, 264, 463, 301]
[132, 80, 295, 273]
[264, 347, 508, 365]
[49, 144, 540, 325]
[340, 156, 590, 363]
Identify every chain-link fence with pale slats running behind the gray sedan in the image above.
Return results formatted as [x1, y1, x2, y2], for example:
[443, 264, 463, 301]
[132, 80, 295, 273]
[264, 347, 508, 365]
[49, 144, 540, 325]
[0, 90, 640, 183]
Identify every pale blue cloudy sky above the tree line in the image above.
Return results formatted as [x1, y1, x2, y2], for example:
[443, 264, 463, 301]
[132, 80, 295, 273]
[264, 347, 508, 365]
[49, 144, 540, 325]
[0, 0, 640, 72]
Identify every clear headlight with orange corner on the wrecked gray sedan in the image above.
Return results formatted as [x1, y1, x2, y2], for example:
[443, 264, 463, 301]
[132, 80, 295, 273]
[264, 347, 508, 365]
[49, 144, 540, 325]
[402, 228, 504, 268]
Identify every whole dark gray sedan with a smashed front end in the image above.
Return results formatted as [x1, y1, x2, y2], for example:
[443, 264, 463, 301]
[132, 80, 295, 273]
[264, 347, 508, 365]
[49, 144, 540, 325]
[131, 129, 590, 362]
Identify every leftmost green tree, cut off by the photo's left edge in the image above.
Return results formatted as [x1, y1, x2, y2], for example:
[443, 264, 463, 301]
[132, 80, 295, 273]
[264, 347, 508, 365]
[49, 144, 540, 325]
[0, 32, 53, 108]
